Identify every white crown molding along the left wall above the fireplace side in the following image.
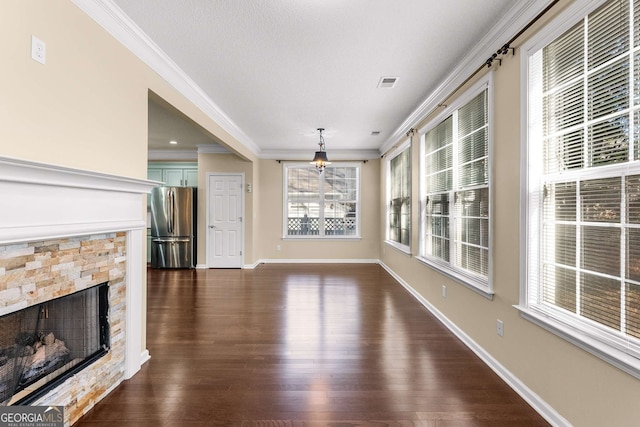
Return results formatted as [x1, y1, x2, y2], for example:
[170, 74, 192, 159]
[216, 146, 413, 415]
[73, 0, 260, 156]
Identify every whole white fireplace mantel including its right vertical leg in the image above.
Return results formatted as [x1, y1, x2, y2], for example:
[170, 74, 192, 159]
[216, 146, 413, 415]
[0, 157, 160, 378]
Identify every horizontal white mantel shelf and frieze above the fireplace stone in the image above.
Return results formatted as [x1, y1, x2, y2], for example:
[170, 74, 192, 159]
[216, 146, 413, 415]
[0, 157, 160, 244]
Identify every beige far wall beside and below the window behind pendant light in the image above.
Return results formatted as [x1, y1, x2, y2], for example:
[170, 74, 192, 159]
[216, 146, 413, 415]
[258, 159, 380, 260]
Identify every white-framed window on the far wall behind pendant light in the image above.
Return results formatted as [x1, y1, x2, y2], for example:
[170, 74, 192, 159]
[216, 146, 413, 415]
[284, 164, 360, 238]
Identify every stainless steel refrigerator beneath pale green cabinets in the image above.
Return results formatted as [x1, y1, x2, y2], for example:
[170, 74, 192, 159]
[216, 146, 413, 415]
[150, 187, 196, 268]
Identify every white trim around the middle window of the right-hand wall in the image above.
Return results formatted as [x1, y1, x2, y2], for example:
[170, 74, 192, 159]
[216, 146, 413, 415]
[416, 71, 494, 299]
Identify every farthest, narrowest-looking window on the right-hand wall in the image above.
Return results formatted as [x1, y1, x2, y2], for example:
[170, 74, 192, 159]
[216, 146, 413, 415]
[387, 143, 411, 252]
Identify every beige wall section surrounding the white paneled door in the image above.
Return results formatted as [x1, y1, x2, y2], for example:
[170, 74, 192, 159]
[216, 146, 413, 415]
[198, 154, 257, 265]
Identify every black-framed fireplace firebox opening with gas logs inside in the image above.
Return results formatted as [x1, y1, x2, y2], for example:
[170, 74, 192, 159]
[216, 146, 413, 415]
[0, 283, 110, 405]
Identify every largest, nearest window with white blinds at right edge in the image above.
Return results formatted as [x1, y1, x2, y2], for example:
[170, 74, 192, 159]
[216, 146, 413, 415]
[520, 0, 640, 376]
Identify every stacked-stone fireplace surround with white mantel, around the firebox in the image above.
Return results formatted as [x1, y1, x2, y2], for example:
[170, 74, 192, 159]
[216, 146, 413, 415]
[0, 157, 157, 425]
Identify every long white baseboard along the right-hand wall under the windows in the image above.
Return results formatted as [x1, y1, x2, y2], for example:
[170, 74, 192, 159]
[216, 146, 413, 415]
[380, 262, 571, 427]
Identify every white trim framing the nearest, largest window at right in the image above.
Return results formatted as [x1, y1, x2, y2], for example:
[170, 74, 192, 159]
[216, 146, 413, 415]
[514, 0, 640, 379]
